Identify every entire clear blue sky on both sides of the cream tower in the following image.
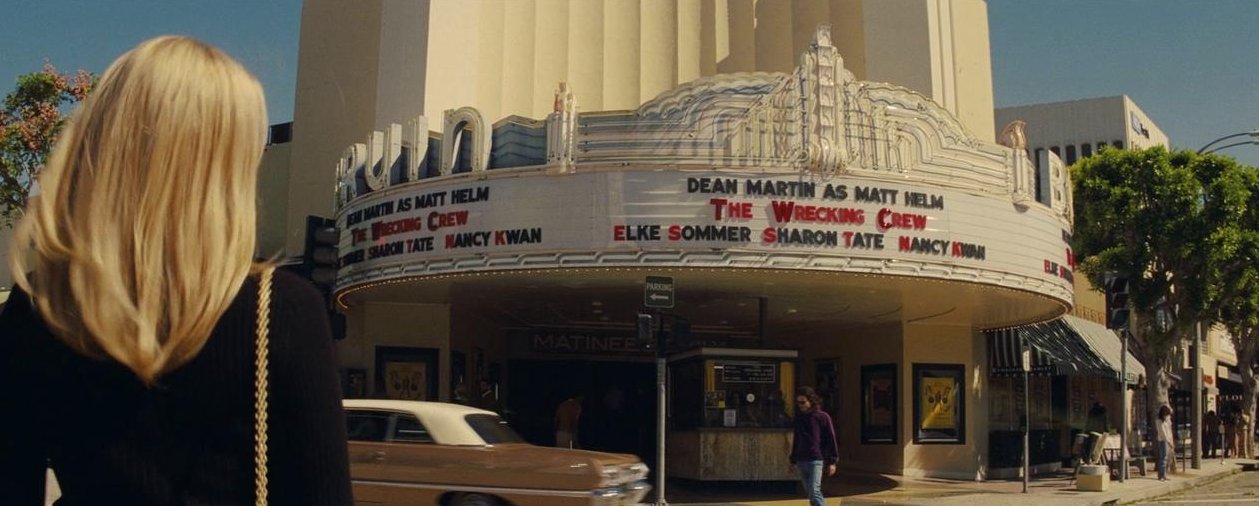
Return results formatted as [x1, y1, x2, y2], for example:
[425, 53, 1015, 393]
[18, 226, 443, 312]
[0, 0, 1259, 166]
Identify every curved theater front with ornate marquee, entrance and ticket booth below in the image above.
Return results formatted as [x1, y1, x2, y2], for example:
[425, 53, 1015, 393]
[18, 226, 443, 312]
[324, 29, 1073, 480]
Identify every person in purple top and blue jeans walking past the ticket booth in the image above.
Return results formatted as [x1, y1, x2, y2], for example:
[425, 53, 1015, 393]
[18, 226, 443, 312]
[791, 386, 840, 506]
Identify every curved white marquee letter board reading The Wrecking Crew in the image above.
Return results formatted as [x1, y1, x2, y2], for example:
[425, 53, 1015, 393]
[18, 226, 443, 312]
[337, 167, 1073, 303]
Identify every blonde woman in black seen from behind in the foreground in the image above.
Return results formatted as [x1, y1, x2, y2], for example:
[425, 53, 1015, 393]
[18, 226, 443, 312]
[0, 37, 351, 506]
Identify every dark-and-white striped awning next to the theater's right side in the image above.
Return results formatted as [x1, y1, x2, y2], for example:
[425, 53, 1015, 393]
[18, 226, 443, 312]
[986, 316, 1146, 383]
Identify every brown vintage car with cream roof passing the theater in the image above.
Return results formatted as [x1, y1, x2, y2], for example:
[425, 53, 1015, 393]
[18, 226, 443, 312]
[344, 399, 651, 506]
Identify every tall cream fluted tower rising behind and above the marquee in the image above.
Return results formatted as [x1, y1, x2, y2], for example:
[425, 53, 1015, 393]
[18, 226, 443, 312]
[262, 0, 992, 257]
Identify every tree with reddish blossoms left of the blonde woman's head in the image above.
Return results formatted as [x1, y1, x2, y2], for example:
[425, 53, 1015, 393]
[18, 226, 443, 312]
[0, 63, 96, 227]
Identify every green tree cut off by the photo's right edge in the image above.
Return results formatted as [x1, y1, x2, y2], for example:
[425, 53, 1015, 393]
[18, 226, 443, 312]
[1207, 157, 1259, 458]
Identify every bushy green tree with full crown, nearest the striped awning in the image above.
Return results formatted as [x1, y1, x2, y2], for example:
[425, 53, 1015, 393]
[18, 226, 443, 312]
[1071, 147, 1245, 435]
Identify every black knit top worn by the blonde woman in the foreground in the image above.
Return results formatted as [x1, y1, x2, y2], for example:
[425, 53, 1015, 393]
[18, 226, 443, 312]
[0, 271, 351, 506]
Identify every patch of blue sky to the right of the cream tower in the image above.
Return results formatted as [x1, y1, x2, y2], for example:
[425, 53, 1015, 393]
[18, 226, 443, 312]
[988, 0, 1259, 166]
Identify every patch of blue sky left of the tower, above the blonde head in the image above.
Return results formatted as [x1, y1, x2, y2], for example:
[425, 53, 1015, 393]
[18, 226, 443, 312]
[0, 0, 302, 123]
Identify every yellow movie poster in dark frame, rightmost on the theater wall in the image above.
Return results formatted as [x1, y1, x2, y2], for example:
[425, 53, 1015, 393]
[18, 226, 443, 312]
[914, 364, 966, 444]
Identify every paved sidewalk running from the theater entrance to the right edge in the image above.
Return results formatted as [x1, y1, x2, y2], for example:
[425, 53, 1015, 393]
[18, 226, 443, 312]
[665, 458, 1259, 506]
